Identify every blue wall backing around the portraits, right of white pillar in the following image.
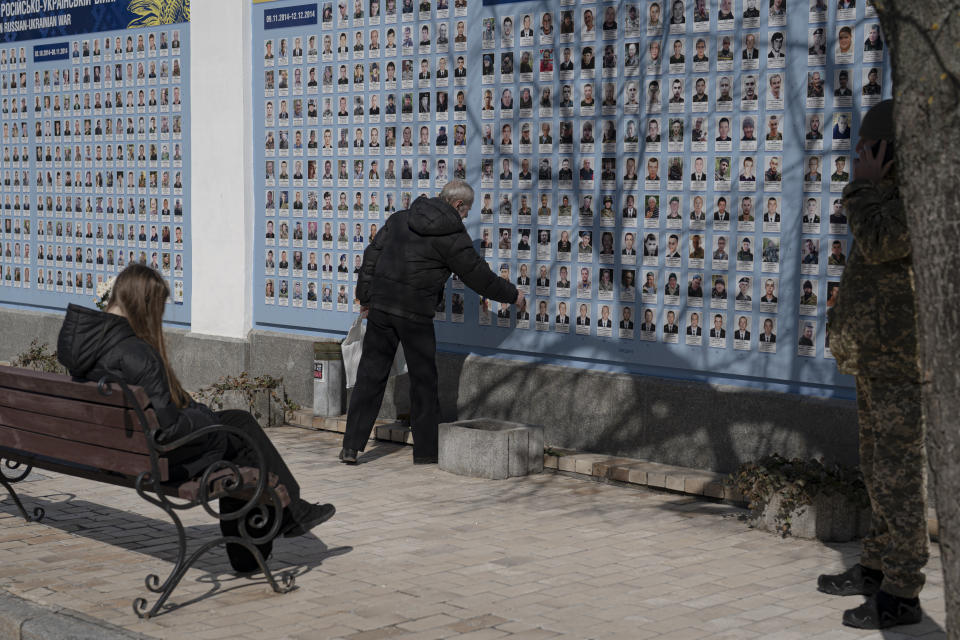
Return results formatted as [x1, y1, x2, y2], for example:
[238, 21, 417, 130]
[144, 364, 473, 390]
[252, 0, 890, 396]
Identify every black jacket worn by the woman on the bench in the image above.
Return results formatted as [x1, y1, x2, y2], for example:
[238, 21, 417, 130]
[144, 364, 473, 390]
[57, 304, 227, 477]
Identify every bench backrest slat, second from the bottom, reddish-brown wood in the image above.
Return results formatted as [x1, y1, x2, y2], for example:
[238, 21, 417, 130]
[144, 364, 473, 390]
[0, 406, 150, 454]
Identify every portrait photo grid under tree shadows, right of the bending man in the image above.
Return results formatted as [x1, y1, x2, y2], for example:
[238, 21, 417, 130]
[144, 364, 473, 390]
[479, 0, 883, 356]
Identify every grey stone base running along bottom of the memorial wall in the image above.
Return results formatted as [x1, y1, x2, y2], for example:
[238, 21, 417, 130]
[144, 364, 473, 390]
[0, 310, 857, 472]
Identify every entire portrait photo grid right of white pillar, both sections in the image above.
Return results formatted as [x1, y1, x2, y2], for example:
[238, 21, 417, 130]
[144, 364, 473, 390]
[258, 0, 884, 368]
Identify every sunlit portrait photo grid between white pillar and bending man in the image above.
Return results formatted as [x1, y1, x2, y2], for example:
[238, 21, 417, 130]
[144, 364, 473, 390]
[257, 0, 469, 311]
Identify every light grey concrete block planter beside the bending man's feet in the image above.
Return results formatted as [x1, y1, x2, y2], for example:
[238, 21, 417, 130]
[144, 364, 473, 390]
[439, 419, 543, 480]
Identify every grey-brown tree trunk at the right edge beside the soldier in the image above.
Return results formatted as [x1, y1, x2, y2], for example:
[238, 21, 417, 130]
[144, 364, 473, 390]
[875, 0, 960, 639]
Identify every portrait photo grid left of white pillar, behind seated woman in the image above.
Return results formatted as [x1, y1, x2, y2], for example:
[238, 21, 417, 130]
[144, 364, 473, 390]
[0, 27, 187, 305]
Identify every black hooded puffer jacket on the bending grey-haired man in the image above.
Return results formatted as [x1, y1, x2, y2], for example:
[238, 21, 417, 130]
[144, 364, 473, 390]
[357, 196, 517, 322]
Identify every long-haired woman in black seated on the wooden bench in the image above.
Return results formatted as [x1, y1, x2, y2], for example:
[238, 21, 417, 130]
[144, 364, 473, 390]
[57, 264, 335, 572]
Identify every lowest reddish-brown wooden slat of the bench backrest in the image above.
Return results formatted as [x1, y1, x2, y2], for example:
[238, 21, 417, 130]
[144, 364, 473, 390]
[0, 426, 170, 482]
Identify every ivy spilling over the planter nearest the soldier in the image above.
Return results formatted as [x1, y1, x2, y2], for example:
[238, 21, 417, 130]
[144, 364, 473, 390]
[726, 453, 870, 538]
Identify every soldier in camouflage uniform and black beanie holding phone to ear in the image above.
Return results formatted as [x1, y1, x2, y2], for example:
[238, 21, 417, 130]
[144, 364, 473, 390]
[818, 100, 929, 629]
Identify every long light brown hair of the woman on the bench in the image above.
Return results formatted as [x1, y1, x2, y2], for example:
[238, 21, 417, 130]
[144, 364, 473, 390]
[107, 264, 190, 409]
